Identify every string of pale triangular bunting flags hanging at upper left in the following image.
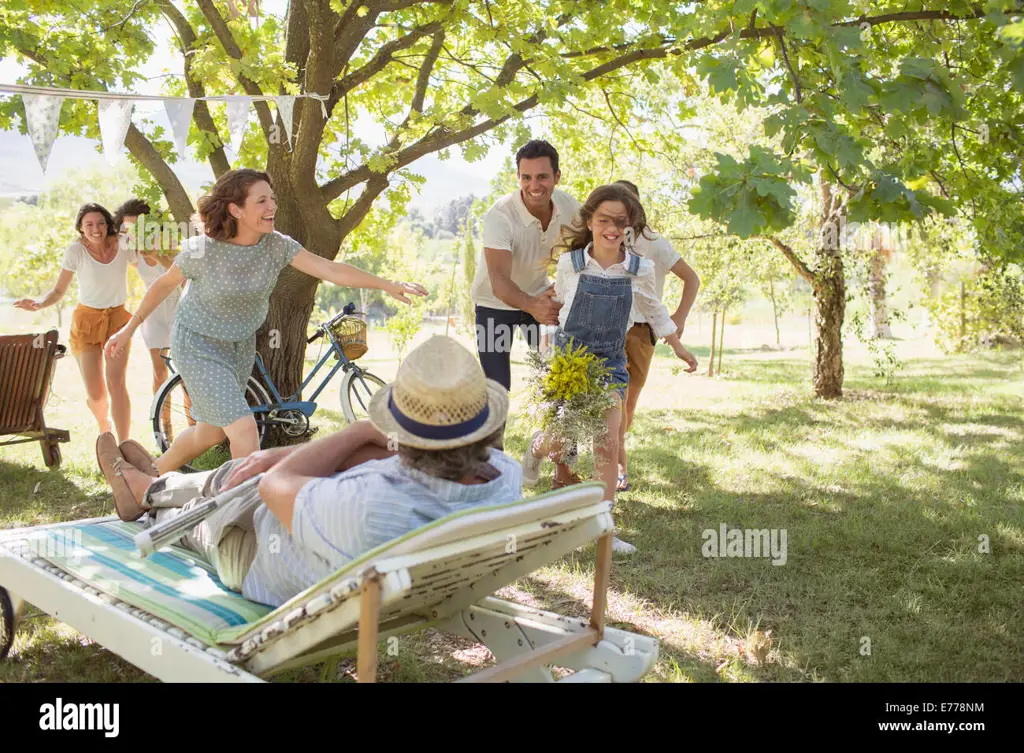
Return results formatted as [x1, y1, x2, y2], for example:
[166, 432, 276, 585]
[0, 84, 329, 174]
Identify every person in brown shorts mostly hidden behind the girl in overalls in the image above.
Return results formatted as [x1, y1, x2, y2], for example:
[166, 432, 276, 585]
[615, 180, 700, 492]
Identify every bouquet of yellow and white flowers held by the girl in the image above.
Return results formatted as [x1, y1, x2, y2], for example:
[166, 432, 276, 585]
[526, 340, 623, 450]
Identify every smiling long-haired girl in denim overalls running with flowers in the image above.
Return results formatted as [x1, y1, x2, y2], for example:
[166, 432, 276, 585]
[523, 184, 697, 553]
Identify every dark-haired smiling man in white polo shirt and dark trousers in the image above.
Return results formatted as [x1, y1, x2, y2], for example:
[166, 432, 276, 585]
[471, 140, 580, 465]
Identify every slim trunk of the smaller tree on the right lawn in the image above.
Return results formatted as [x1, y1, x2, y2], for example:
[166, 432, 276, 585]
[813, 186, 846, 400]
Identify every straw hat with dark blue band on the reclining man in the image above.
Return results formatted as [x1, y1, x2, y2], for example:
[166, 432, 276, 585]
[367, 335, 509, 450]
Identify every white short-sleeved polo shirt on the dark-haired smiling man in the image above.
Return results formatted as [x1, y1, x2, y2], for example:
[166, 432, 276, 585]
[471, 189, 581, 311]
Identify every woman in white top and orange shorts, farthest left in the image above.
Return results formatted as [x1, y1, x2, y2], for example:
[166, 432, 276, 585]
[14, 204, 135, 442]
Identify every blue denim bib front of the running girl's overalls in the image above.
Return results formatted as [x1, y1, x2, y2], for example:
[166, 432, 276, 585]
[555, 275, 633, 357]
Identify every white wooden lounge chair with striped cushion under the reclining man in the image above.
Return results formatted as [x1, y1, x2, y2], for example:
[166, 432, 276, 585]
[0, 483, 658, 682]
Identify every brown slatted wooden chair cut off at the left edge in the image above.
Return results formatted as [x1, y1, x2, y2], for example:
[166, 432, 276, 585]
[0, 330, 71, 468]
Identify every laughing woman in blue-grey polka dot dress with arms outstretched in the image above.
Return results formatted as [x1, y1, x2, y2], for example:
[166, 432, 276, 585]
[106, 169, 427, 473]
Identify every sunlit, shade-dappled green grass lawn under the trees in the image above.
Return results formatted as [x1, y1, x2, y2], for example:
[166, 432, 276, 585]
[0, 311, 1024, 682]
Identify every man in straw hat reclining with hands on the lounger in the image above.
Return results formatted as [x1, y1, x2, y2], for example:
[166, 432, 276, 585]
[96, 336, 522, 606]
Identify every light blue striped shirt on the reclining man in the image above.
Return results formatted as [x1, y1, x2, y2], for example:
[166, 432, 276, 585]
[242, 450, 522, 606]
